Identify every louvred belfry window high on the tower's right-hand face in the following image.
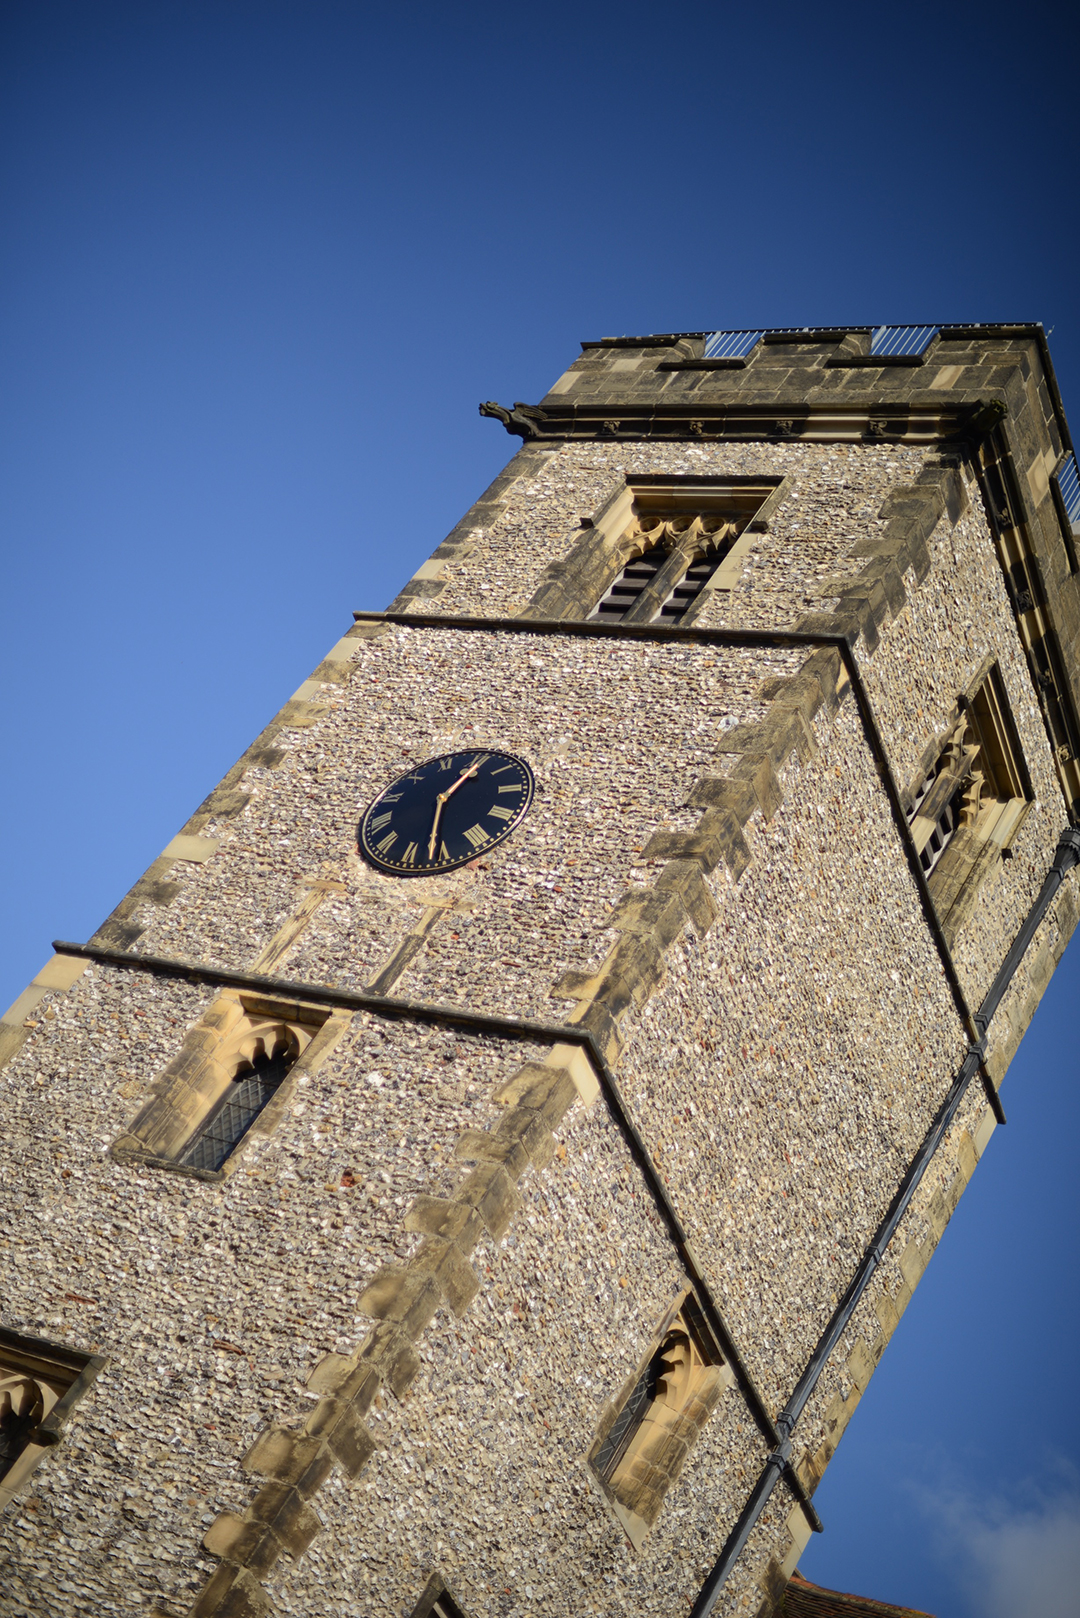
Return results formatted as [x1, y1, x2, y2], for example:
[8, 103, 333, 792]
[907, 667, 1033, 934]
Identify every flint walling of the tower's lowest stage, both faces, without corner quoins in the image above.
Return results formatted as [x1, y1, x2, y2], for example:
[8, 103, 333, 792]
[0, 966, 764, 1618]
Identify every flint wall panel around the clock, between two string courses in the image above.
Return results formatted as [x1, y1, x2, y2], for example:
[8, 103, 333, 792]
[122, 628, 805, 1019]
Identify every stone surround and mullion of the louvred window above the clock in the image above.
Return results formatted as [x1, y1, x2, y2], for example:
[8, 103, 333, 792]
[521, 472, 790, 626]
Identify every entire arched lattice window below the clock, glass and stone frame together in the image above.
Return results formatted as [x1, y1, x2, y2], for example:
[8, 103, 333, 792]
[112, 992, 333, 1176]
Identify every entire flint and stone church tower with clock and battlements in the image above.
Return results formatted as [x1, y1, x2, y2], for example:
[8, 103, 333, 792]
[0, 325, 1080, 1618]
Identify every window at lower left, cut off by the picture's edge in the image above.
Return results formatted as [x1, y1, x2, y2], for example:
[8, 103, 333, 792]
[0, 1330, 105, 1511]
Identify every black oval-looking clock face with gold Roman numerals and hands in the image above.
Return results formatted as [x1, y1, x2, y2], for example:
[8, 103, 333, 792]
[356, 748, 536, 877]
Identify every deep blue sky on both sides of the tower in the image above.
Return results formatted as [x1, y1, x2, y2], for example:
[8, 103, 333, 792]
[0, 0, 1080, 1618]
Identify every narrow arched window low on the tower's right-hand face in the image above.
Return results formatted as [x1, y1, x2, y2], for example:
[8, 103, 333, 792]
[589, 1294, 730, 1545]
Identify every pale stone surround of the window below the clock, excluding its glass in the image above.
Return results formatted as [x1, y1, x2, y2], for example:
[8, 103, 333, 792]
[110, 989, 345, 1181]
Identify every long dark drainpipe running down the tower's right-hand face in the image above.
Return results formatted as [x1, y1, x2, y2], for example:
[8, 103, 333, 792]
[690, 825, 1080, 1618]
